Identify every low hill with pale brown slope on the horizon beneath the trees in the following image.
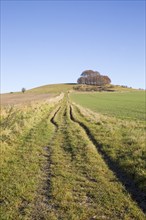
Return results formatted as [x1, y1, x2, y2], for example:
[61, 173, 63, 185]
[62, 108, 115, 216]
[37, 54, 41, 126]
[1, 83, 141, 105]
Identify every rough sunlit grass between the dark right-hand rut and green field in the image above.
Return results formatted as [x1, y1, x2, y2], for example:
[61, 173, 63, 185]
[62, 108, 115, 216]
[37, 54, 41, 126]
[71, 103, 146, 196]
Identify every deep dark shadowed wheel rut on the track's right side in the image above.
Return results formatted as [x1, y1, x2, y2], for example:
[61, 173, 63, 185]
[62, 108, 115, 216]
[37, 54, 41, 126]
[70, 106, 146, 213]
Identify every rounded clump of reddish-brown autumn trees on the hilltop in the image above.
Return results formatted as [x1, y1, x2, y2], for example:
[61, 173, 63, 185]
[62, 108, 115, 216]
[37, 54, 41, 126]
[77, 70, 111, 86]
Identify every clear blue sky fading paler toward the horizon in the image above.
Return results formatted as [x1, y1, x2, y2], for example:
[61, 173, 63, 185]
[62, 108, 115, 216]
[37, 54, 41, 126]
[1, 0, 145, 93]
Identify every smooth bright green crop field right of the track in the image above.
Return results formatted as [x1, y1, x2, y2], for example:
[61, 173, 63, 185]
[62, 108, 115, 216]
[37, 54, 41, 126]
[71, 91, 146, 120]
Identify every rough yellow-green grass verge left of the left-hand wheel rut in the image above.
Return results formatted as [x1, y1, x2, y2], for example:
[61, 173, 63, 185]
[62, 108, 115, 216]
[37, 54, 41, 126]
[0, 103, 58, 219]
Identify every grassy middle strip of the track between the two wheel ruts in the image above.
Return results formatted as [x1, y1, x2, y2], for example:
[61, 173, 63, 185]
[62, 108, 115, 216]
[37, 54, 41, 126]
[35, 101, 144, 220]
